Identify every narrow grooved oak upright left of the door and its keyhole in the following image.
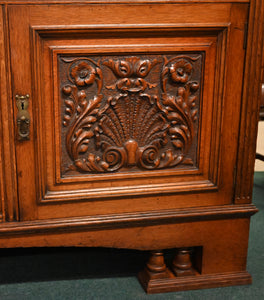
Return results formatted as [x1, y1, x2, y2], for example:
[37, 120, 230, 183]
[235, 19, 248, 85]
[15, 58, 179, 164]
[0, 4, 19, 222]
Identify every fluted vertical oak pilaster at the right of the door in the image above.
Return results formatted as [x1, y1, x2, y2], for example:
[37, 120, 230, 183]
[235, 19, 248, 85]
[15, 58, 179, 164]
[235, 0, 264, 203]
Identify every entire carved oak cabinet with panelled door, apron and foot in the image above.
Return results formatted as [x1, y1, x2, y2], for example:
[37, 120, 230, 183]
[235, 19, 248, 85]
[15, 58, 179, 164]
[0, 0, 263, 293]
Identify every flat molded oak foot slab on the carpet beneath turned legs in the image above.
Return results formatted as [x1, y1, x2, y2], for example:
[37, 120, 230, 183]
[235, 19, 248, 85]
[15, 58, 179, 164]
[138, 269, 252, 294]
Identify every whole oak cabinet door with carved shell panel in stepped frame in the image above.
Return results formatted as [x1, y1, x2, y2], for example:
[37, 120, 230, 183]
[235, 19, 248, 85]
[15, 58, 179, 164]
[8, 3, 248, 220]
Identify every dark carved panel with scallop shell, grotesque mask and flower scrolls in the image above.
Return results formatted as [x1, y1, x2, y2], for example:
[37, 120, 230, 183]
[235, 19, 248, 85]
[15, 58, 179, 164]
[59, 54, 203, 173]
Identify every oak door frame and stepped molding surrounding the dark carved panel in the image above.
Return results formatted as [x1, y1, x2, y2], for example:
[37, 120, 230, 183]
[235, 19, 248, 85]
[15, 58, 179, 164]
[8, 4, 248, 220]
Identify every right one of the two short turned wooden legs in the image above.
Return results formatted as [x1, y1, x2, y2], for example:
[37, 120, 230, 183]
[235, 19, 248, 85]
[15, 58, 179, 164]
[172, 248, 195, 276]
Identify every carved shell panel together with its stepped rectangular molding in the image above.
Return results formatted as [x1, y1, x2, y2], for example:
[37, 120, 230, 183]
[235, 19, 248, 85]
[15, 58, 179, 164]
[28, 25, 228, 203]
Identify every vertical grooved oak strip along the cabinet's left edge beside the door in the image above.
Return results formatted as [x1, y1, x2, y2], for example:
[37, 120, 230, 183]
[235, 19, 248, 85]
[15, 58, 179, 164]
[0, 6, 18, 221]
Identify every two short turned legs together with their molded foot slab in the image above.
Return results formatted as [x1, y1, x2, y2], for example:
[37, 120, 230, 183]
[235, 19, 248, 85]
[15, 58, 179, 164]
[138, 244, 251, 294]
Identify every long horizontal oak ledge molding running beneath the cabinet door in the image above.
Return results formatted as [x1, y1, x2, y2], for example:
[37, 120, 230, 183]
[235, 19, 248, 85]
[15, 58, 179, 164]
[0, 204, 258, 236]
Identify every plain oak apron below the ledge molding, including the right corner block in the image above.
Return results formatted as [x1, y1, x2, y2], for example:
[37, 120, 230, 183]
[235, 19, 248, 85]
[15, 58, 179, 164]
[0, 218, 254, 292]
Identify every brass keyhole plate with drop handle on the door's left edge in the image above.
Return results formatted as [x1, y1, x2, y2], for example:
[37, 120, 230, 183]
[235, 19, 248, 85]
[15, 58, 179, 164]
[16, 94, 30, 141]
